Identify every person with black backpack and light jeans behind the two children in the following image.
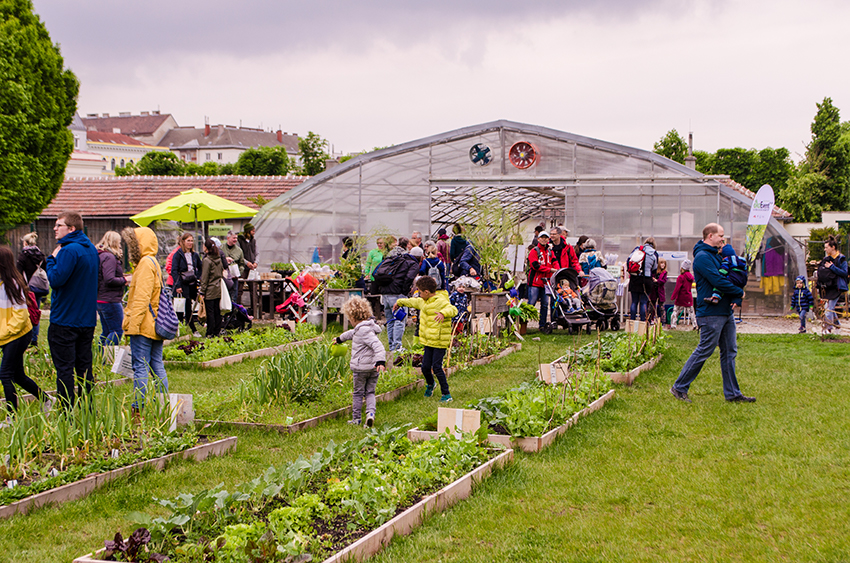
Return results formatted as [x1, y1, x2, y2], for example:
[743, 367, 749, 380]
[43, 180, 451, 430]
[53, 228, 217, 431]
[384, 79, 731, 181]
[372, 237, 419, 353]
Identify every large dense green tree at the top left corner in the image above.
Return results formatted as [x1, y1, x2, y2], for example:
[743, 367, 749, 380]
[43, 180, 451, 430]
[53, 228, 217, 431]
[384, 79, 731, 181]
[0, 0, 79, 232]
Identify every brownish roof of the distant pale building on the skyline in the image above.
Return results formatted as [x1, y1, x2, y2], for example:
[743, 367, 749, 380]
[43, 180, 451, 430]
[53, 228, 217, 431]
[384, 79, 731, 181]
[159, 125, 298, 154]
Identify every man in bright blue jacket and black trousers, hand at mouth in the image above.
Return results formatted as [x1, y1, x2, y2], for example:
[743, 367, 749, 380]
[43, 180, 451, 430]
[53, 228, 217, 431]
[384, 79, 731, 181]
[44, 211, 99, 407]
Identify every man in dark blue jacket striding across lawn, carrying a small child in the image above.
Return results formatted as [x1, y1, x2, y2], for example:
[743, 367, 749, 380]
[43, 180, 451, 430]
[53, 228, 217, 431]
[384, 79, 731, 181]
[670, 223, 756, 403]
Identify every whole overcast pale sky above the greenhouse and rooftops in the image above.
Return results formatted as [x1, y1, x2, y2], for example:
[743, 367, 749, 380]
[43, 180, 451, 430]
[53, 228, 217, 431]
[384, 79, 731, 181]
[33, 0, 850, 160]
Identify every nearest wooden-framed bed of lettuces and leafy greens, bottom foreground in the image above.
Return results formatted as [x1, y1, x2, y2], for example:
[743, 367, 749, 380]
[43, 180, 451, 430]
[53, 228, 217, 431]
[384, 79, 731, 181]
[75, 428, 513, 563]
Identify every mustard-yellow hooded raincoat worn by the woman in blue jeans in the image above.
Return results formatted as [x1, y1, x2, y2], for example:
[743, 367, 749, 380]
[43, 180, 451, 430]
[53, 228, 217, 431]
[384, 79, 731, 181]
[123, 227, 162, 340]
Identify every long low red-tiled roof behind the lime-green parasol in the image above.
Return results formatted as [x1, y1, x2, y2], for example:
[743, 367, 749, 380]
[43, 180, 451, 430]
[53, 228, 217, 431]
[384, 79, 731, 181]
[41, 176, 309, 218]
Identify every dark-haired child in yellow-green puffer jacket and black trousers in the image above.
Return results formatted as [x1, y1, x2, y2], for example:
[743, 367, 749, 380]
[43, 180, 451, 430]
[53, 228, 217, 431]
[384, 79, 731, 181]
[393, 276, 457, 403]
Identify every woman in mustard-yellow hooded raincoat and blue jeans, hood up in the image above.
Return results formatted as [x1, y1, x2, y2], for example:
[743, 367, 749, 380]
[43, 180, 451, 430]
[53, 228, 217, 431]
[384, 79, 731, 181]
[121, 227, 168, 409]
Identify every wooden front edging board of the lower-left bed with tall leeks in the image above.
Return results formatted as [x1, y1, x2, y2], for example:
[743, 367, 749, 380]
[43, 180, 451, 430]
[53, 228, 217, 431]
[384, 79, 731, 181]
[0, 436, 236, 518]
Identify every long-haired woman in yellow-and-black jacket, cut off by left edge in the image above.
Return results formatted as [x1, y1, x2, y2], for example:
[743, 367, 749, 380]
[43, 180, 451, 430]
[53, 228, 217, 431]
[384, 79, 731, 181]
[0, 246, 53, 427]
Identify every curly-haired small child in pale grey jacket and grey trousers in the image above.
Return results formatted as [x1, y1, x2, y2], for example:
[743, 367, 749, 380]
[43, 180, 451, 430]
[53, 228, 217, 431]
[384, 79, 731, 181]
[336, 297, 386, 428]
